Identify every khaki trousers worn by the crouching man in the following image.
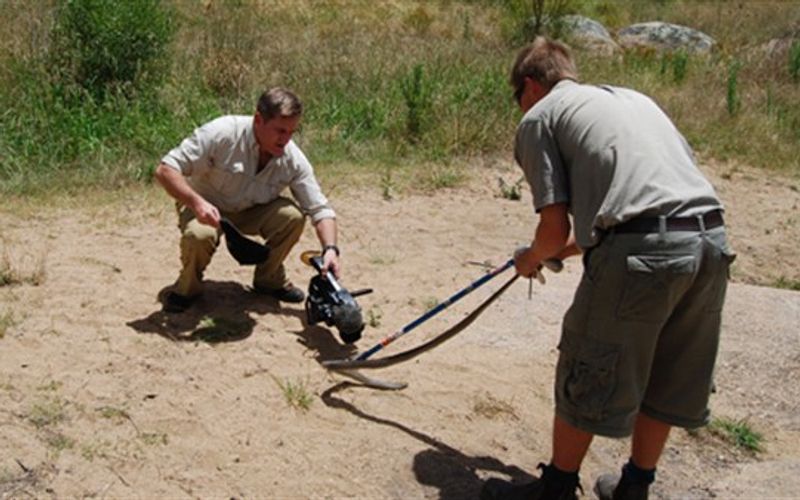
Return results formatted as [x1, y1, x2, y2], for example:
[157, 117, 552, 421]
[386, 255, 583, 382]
[175, 197, 305, 297]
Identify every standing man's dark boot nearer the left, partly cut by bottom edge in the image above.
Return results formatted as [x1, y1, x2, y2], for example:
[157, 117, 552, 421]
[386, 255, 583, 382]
[480, 464, 580, 500]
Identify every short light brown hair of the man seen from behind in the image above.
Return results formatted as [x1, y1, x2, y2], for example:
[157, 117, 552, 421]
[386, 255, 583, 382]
[510, 36, 578, 89]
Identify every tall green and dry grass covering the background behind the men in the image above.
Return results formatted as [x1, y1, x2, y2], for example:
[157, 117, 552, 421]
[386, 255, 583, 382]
[0, 0, 800, 199]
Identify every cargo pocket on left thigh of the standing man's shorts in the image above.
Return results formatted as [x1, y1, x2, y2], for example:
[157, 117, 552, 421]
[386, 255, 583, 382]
[556, 337, 620, 421]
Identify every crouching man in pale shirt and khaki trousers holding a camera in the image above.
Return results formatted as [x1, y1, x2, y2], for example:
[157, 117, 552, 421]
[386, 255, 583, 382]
[155, 88, 340, 312]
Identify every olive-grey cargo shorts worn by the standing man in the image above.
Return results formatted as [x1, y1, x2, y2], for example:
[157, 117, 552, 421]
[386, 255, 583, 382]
[555, 226, 735, 437]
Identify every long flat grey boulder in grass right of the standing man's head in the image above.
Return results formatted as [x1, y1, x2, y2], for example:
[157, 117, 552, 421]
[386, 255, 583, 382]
[617, 21, 717, 54]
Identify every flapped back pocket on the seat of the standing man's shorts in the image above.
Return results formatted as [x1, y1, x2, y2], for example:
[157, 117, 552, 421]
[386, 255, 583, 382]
[617, 255, 697, 323]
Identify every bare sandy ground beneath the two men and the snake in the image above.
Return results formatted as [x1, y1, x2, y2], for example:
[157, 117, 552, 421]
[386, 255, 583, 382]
[0, 164, 800, 499]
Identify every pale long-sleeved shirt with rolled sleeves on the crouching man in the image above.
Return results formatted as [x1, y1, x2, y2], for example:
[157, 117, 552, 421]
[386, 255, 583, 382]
[161, 115, 336, 222]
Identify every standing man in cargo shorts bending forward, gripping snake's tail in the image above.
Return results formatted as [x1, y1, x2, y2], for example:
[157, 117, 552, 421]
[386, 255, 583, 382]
[481, 37, 734, 499]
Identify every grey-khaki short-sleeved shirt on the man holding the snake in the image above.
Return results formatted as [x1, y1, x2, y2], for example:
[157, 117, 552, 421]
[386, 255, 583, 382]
[515, 80, 722, 249]
